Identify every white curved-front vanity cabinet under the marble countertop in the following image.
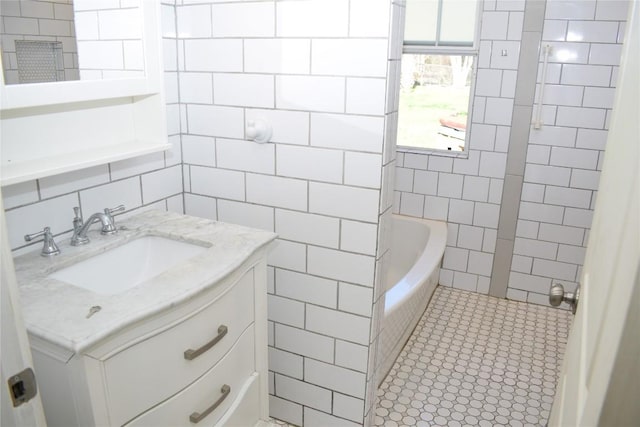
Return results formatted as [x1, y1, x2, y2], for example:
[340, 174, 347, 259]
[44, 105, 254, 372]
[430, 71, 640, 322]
[31, 248, 268, 427]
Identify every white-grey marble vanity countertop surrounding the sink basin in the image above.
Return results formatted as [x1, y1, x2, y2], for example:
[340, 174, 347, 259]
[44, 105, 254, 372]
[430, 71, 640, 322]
[14, 210, 276, 352]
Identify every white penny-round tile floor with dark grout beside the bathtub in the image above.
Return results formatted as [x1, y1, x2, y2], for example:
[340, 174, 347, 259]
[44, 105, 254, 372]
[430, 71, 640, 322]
[375, 287, 572, 427]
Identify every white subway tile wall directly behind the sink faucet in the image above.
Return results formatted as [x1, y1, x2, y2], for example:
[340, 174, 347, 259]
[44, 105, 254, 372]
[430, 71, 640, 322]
[2, 2, 183, 253]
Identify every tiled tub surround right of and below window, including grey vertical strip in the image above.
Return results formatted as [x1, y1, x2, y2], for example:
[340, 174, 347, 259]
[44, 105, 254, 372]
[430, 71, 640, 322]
[394, 0, 628, 308]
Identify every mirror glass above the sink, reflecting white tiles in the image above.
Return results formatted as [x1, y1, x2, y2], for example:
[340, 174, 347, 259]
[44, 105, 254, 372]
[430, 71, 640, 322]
[0, 0, 145, 85]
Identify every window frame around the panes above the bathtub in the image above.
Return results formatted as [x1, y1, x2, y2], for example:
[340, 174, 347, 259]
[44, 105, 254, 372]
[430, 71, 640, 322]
[396, 0, 484, 158]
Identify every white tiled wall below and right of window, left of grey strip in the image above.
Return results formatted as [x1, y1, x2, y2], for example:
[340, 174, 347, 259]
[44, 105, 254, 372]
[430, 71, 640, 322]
[394, 1, 525, 293]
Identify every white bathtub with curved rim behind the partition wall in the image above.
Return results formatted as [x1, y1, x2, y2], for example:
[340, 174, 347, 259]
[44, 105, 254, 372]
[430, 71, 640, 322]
[378, 215, 447, 382]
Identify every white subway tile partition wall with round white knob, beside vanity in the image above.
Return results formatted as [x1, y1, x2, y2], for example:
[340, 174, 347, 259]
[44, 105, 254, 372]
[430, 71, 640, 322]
[177, 0, 393, 425]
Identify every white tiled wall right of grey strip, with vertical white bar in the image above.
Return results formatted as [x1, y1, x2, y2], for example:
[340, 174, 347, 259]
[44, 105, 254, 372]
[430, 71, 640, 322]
[507, 0, 629, 304]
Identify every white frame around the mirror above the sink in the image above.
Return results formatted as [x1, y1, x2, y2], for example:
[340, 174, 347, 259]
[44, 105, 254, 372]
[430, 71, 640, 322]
[0, 0, 163, 110]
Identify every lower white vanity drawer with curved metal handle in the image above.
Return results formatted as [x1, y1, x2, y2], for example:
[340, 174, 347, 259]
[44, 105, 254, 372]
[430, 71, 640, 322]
[127, 326, 259, 427]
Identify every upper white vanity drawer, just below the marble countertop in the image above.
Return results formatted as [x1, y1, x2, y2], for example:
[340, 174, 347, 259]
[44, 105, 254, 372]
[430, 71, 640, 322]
[104, 270, 254, 425]
